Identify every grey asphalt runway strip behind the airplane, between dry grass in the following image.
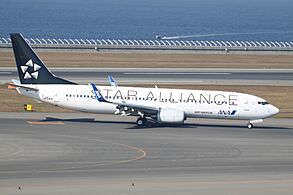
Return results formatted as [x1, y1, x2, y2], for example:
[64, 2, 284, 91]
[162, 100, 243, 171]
[0, 68, 293, 86]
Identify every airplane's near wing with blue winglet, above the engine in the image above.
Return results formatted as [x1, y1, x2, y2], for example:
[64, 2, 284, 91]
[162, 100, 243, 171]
[90, 83, 160, 115]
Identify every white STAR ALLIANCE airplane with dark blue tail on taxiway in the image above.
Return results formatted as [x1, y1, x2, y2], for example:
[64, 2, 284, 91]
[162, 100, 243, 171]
[10, 33, 279, 129]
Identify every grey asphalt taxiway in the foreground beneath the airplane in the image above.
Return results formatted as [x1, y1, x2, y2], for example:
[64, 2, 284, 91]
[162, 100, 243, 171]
[0, 113, 293, 195]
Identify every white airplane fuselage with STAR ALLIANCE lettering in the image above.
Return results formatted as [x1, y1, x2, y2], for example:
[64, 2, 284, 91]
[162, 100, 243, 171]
[17, 84, 279, 120]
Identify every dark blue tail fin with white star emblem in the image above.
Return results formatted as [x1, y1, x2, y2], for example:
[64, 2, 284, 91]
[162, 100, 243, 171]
[10, 33, 75, 84]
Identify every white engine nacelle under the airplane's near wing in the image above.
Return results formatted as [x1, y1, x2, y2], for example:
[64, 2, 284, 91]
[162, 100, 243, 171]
[157, 108, 185, 123]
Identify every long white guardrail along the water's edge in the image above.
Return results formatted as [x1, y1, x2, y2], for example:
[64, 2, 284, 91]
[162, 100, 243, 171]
[0, 38, 293, 51]
